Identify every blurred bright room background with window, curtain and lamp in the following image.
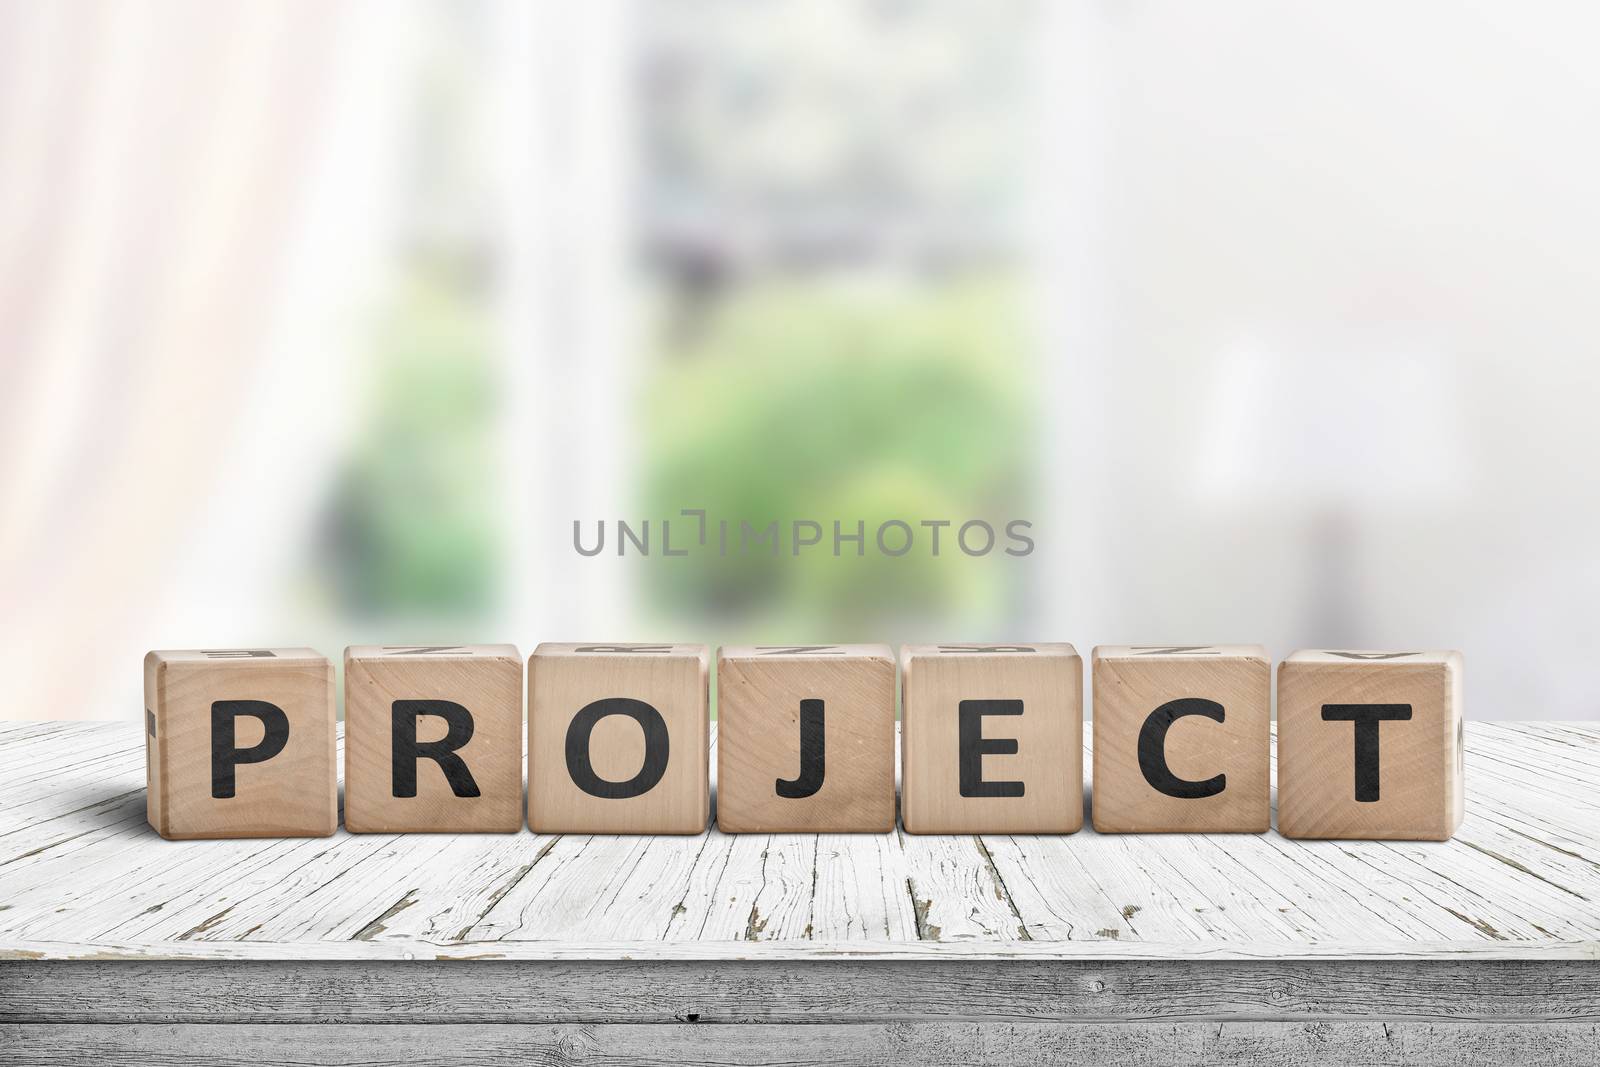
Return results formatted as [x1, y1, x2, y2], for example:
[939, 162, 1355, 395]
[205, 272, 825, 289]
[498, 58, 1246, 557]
[0, 0, 1600, 718]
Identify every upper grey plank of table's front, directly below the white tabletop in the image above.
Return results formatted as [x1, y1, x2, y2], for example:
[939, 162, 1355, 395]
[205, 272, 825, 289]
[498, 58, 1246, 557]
[0, 958, 1600, 1024]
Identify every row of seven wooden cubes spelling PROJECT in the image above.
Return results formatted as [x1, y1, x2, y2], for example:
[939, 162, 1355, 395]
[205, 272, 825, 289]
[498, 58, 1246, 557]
[146, 645, 1464, 840]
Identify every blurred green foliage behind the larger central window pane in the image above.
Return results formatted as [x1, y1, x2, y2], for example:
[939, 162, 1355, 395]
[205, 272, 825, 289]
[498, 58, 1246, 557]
[642, 277, 1032, 640]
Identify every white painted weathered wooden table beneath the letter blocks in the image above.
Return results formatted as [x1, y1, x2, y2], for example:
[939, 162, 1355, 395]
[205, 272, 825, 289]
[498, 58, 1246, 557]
[0, 723, 1600, 1065]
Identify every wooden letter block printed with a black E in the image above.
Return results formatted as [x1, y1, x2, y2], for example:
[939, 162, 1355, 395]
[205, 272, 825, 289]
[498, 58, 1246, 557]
[901, 645, 1083, 833]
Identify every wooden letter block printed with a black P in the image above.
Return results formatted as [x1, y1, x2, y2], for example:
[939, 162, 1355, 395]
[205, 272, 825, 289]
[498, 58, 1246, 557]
[144, 648, 339, 840]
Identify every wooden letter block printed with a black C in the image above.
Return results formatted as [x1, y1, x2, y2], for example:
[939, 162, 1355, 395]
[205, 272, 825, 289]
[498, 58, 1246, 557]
[1091, 645, 1272, 833]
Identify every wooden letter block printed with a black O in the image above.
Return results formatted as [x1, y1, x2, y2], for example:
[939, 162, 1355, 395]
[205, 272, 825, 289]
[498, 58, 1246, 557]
[528, 645, 710, 833]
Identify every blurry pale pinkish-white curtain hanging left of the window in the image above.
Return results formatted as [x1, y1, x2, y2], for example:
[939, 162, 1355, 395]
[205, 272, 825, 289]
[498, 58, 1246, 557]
[0, 0, 336, 718]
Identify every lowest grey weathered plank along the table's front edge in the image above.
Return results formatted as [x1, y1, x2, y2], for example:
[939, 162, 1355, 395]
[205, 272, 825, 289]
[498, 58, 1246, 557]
[0, 1021, 1600, 1067]
